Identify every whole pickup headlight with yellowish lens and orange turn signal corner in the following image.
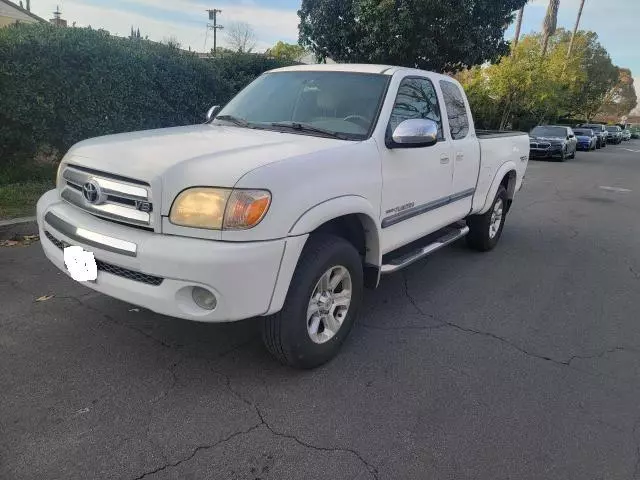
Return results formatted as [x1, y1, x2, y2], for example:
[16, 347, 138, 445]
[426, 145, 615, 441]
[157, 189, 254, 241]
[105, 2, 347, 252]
[169, 187, 271, 230]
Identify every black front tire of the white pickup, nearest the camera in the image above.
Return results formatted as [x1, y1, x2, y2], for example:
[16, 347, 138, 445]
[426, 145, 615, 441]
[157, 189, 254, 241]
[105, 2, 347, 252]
[262, 234, 363, 369]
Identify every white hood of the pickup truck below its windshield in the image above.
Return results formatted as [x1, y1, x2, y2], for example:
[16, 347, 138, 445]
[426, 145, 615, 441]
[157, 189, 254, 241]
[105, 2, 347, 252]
[65, 124, 352, 187]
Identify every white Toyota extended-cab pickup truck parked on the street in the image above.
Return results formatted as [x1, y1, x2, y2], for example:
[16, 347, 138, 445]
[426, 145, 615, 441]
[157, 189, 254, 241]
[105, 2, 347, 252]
[37, 65, 529, 368]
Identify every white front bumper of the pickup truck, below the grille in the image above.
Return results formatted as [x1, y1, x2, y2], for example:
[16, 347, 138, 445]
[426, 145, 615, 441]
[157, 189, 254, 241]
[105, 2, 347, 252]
[37, 190, 307, 322]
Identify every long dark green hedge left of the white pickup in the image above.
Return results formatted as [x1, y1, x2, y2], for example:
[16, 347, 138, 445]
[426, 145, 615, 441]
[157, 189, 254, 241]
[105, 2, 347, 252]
[0, 24, 292, 183]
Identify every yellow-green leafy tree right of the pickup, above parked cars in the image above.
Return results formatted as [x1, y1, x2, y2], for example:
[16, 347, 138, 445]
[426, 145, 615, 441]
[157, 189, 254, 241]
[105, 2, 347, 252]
[458, 30, 616, 129]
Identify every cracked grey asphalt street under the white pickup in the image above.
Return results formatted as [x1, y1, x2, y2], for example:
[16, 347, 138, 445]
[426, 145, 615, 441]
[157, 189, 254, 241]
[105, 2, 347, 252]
[0, 141, 640, 480]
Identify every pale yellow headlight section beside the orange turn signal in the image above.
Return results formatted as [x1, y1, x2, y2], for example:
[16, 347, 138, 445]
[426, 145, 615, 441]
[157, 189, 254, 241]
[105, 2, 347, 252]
[169, 188, 231, 230]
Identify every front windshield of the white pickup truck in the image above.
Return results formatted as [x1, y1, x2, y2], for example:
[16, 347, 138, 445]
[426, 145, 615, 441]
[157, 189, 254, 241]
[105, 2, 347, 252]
[218, 71, 390, 140]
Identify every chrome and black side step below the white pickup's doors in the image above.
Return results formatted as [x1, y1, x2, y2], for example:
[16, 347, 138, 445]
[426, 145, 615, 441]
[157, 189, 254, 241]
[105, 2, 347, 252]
[380, 224, 469, 275]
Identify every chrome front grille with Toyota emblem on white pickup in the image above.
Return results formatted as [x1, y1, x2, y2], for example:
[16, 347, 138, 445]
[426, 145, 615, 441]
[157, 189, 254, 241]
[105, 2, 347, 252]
[59, 165, 154, 230]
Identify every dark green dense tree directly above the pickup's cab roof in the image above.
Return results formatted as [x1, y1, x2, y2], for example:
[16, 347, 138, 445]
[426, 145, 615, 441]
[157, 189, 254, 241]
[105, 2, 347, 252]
[298, 0, 526, 72]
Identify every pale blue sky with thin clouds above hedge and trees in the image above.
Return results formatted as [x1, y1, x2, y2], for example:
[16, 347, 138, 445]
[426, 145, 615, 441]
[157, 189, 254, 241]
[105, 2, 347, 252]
[22, 0, 640, 112]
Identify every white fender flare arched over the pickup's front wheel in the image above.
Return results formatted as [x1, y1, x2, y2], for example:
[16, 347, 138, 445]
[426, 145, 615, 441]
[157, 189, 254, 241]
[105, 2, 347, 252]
[288, 195, 382, 266]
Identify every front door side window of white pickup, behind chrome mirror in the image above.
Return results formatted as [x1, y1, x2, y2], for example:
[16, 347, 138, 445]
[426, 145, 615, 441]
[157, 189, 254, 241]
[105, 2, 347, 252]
[389, 77, 444, 140]
